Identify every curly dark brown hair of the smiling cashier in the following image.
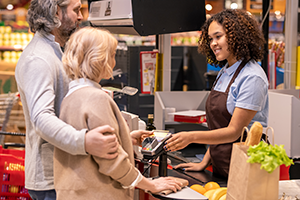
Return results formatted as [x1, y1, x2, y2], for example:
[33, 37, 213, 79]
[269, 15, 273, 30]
[198, 9, 266, 67]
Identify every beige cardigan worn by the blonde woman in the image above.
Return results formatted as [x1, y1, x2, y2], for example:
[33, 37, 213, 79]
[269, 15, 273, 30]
[54, 81, 138, 200]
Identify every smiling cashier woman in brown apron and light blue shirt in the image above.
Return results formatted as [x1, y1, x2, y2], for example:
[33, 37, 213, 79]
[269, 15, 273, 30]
[165, 9, 269, 178]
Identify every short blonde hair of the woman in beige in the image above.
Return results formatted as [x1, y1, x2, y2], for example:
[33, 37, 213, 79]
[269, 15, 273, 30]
[62, 27, 118, 81]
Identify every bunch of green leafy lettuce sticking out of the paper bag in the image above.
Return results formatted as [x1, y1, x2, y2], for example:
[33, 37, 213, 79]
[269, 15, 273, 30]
[247, 141, 294, 173]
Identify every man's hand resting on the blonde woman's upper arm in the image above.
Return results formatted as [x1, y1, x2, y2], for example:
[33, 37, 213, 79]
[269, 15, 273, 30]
[85, 125, 119, 159]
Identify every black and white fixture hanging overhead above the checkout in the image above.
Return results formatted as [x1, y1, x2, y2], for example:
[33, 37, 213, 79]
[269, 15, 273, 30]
[88, 0, 206, 36]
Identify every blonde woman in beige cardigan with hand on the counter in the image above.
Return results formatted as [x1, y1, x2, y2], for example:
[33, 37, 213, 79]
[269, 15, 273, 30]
[54, 27, 181, 200]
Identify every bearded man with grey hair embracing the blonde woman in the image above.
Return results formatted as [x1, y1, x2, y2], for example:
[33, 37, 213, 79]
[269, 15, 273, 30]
[15, 0, 119, 200]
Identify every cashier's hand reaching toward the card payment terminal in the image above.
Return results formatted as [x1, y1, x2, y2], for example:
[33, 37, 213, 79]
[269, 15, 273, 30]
[164, 132, 193, 151]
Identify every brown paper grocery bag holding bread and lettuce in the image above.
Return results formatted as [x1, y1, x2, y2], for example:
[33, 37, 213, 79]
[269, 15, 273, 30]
[226, 143, 279, 200]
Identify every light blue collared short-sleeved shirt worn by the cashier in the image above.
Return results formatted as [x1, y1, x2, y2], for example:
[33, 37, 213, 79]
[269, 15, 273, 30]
[214, 60, 269, 129]
